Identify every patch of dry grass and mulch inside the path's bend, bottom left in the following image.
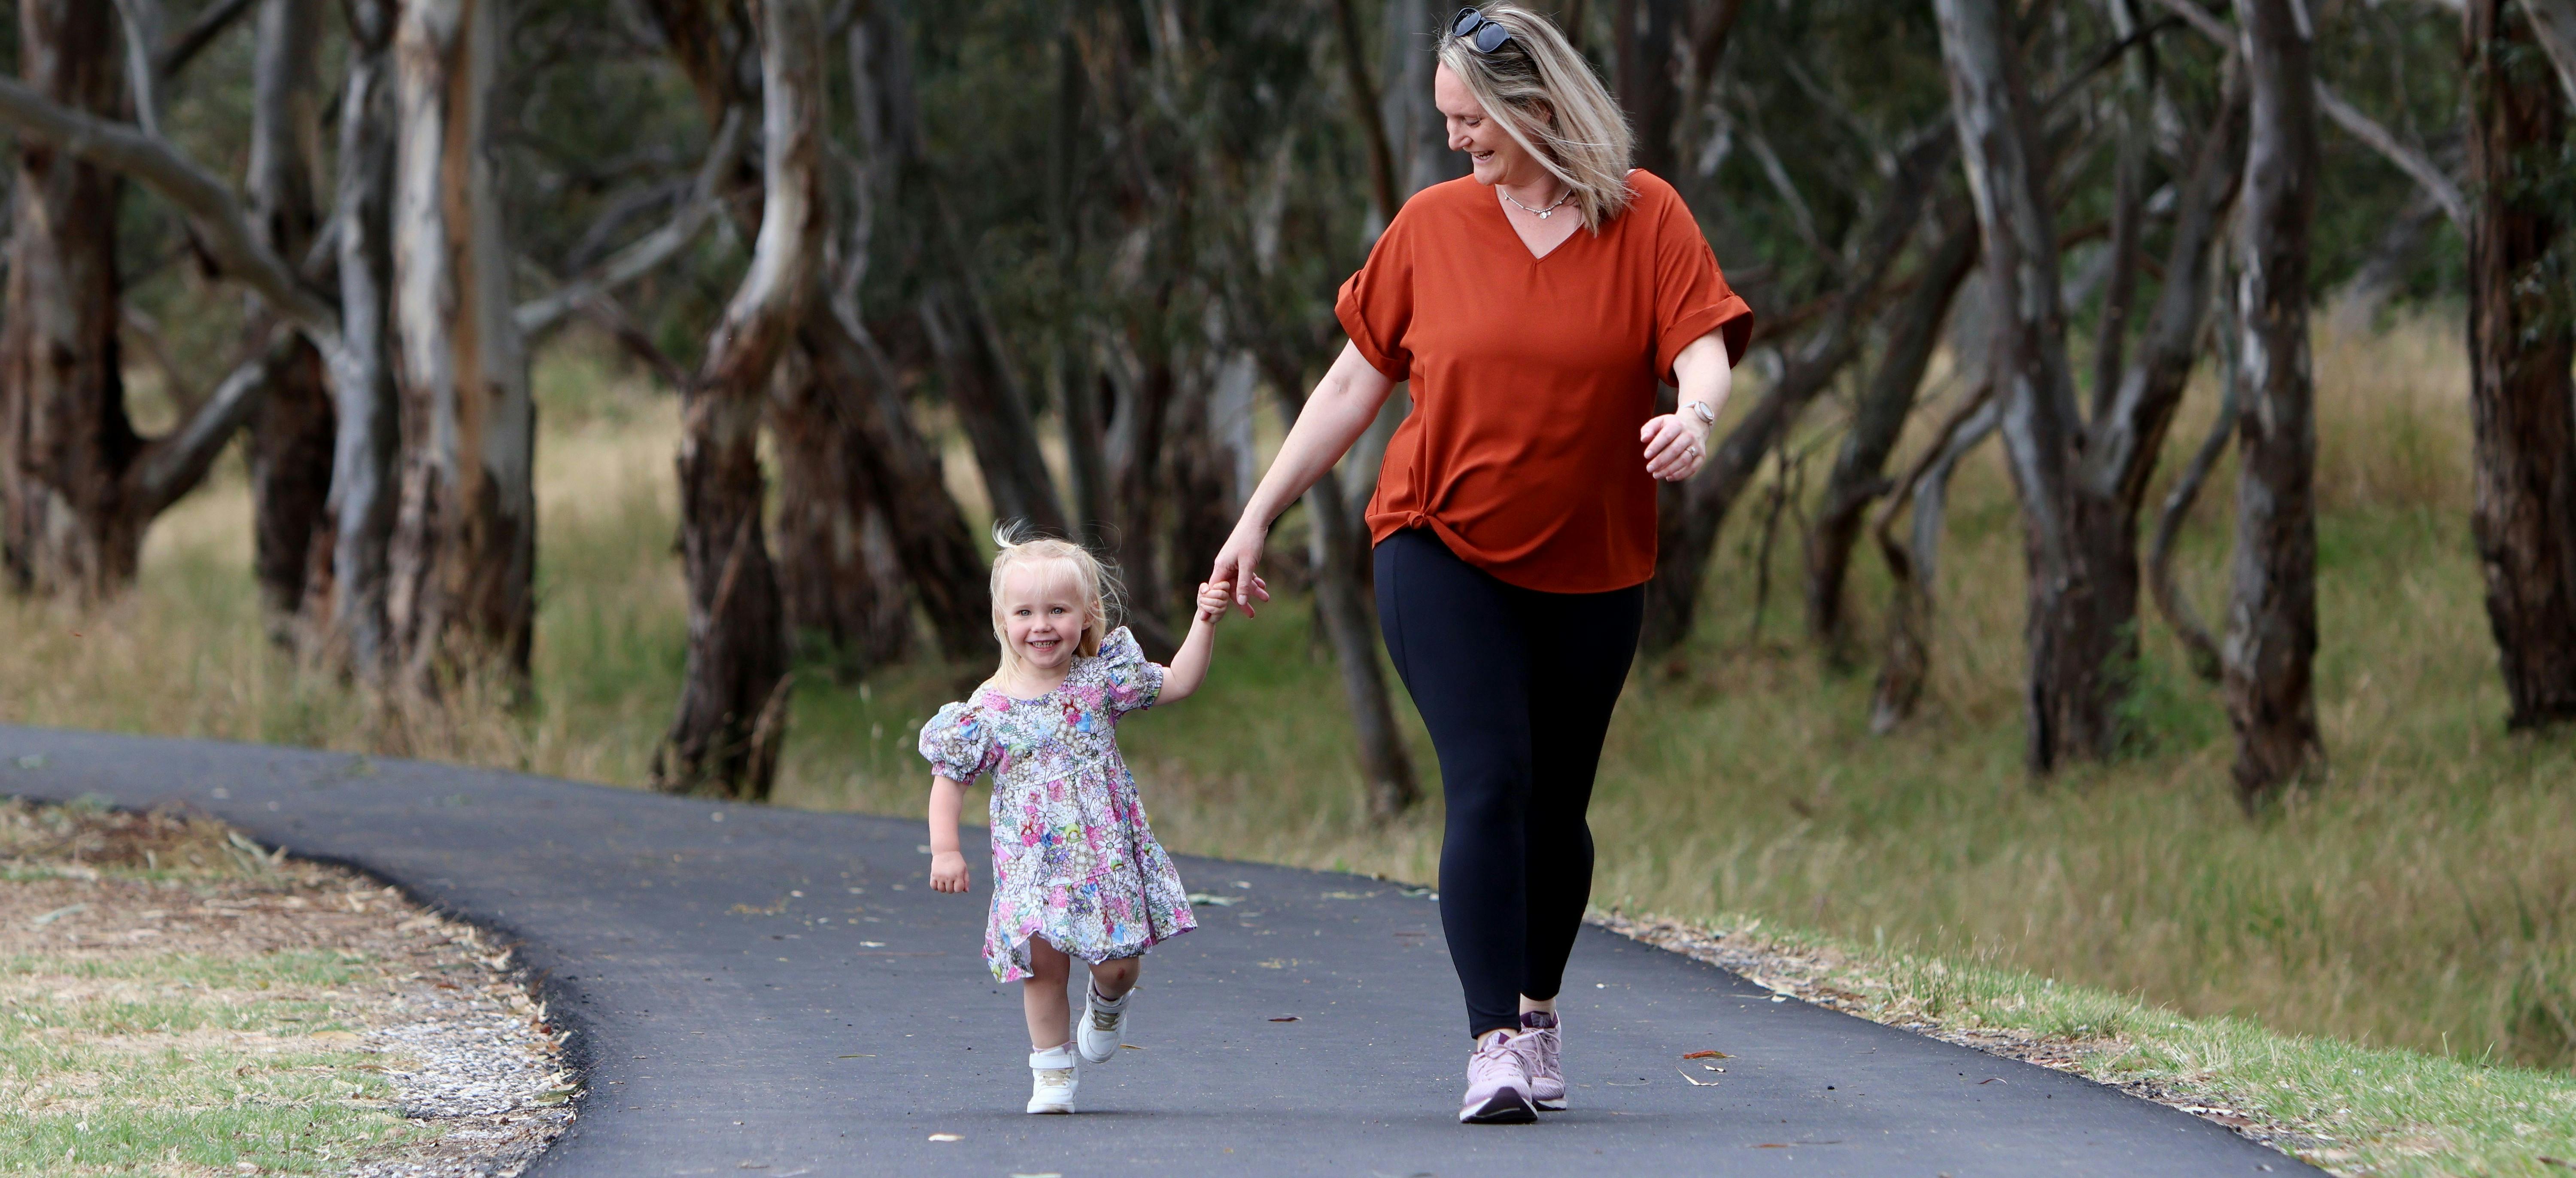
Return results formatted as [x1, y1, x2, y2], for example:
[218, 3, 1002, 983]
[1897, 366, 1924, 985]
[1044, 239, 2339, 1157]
[0, 802, 569, 1175]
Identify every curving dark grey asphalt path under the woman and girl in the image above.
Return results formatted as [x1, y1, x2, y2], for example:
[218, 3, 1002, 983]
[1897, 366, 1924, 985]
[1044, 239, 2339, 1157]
[0, 727, 2316, 1178]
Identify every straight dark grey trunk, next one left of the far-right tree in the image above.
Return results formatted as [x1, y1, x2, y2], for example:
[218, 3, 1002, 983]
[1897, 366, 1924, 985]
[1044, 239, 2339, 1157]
[2223, 0, 2329, 804]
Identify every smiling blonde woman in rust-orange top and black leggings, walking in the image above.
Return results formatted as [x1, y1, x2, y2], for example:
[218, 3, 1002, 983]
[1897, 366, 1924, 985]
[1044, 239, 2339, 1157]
[1211, 3, 1752, 1121]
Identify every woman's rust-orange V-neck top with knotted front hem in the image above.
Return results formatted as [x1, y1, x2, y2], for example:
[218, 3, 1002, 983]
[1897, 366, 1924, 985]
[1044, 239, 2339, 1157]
[1334, 170, 1754, 593]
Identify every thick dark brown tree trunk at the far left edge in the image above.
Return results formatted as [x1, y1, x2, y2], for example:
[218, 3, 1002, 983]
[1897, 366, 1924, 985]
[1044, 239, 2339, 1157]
[0, 0, 147, 601]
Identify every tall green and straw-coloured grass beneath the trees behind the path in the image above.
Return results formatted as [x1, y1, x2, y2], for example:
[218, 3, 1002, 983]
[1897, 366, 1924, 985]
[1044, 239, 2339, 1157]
[0, 317, 2576, 1067]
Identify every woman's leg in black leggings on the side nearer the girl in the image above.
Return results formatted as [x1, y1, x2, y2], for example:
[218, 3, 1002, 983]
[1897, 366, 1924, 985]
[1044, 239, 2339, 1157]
[1376, 531, 1530, 1036]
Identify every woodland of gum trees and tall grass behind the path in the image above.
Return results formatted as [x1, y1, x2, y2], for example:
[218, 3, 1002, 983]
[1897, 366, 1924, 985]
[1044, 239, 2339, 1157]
[0, 0, 2576, 1103]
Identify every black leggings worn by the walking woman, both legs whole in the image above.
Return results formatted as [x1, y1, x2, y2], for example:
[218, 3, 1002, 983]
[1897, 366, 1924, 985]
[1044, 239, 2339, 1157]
[1376, 528, 1646, 1036]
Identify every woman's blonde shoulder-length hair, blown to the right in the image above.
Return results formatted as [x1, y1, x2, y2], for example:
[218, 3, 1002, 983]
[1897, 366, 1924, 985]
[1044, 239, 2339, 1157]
[1440, 3, 1636, 232]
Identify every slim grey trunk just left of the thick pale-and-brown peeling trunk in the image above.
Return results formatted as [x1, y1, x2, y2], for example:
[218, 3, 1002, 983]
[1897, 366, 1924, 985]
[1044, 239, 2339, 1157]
[307, 0, 402, 686]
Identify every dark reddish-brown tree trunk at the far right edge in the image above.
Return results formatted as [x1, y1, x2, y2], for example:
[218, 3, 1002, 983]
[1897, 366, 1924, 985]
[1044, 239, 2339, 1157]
[2465, 0, 2576, 730]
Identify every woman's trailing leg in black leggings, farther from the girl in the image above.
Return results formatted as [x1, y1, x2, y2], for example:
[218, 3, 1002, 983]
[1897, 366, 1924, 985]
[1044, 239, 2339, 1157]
[1520, 585, 1646, 1011]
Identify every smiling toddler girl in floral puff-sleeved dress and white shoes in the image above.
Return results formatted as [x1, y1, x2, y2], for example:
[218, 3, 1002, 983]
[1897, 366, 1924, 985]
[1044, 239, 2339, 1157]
[920, 531, 1231, 1114]
